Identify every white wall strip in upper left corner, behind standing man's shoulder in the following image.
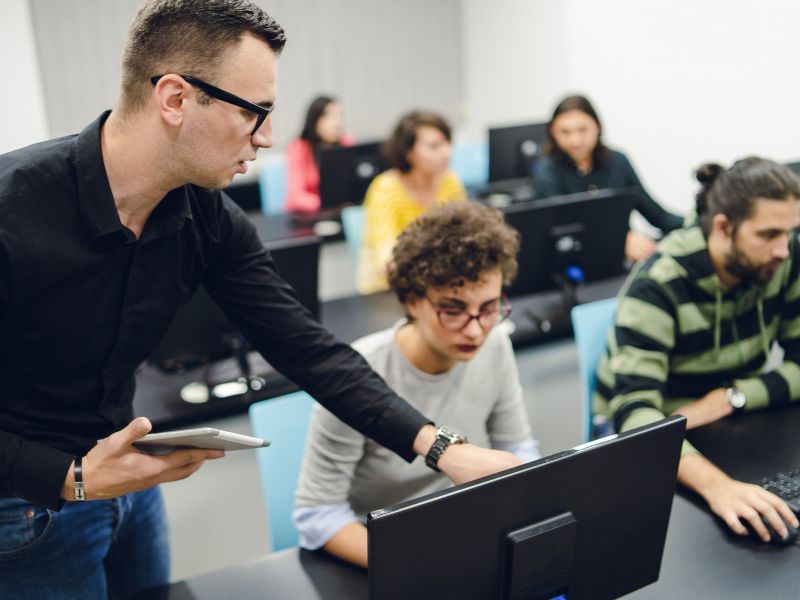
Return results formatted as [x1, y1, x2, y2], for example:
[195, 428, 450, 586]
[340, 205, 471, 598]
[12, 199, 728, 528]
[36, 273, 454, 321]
[0, 0, 47, 154]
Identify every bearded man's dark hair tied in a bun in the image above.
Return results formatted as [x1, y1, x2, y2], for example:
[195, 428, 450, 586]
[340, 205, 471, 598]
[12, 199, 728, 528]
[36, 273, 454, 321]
[695, 156, 800, 237]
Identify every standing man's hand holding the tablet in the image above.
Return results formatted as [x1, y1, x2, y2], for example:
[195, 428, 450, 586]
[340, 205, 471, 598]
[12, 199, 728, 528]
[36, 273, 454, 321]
[61, 417, 225, 500]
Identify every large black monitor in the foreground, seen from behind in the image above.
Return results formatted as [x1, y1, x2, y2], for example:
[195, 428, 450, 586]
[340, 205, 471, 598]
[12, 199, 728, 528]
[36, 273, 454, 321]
[367, 417, 686, 600]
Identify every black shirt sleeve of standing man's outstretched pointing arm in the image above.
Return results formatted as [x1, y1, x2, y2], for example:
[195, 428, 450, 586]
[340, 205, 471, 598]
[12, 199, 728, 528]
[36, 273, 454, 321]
[203, 195, 430, 461]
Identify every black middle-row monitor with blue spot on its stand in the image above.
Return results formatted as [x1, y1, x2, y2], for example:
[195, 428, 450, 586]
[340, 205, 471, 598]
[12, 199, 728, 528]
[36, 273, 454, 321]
[502, 188, 637, 297]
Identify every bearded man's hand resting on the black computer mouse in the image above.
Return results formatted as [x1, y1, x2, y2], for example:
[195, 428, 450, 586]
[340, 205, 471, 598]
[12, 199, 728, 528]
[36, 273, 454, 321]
[678, 454, 798, 542]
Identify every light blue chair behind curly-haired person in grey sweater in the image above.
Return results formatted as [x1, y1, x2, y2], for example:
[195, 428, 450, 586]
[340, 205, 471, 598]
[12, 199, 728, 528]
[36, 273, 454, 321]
[250, 392, 314, 551]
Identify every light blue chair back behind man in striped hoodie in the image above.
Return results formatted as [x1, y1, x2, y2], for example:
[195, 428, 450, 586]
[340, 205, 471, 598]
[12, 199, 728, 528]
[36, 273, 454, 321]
[571, 298, 618, 442]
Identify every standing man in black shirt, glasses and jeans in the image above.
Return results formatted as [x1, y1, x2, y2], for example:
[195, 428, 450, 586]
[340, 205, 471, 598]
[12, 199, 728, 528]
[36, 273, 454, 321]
[0, 0, 518, 598]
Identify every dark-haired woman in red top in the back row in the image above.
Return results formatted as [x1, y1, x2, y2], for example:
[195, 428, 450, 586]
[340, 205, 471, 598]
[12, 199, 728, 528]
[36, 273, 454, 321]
[286, 96, 354, 213]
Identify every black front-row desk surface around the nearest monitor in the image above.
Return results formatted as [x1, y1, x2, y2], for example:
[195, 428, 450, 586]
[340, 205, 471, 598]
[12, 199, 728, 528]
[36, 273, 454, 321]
[148, 407, 800, 600]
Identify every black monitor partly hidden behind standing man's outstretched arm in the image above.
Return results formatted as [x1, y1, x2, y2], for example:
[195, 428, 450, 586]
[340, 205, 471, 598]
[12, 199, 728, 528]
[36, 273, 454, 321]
[148, 236, 320, 372]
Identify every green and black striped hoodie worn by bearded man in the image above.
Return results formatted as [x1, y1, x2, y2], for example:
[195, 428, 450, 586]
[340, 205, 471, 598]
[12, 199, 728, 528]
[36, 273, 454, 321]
[594, 225, 800, 452]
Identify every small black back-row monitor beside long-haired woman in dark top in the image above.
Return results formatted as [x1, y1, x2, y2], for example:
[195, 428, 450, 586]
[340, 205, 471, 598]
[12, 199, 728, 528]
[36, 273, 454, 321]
[489, 123, 547, 181]
